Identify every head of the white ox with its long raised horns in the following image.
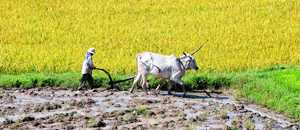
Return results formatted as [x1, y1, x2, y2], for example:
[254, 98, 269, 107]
[180, 45, 204, 70]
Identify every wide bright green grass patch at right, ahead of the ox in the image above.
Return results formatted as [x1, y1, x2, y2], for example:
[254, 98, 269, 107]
[233, 69, 300, 120]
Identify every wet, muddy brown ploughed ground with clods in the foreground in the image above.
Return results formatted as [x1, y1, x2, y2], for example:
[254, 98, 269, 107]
[0, 88, 300, 130]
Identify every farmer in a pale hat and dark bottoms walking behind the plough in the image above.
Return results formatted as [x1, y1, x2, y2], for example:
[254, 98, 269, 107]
[79, 48, 96, 90]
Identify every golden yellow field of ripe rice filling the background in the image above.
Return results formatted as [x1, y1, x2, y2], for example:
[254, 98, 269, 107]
[0, 0, 300, 73]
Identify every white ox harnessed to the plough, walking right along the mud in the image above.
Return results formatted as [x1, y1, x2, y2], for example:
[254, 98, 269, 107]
[130, 52, 198, 96]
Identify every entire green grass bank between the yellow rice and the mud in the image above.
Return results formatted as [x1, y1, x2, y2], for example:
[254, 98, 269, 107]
[0, 66, 300, 120]
